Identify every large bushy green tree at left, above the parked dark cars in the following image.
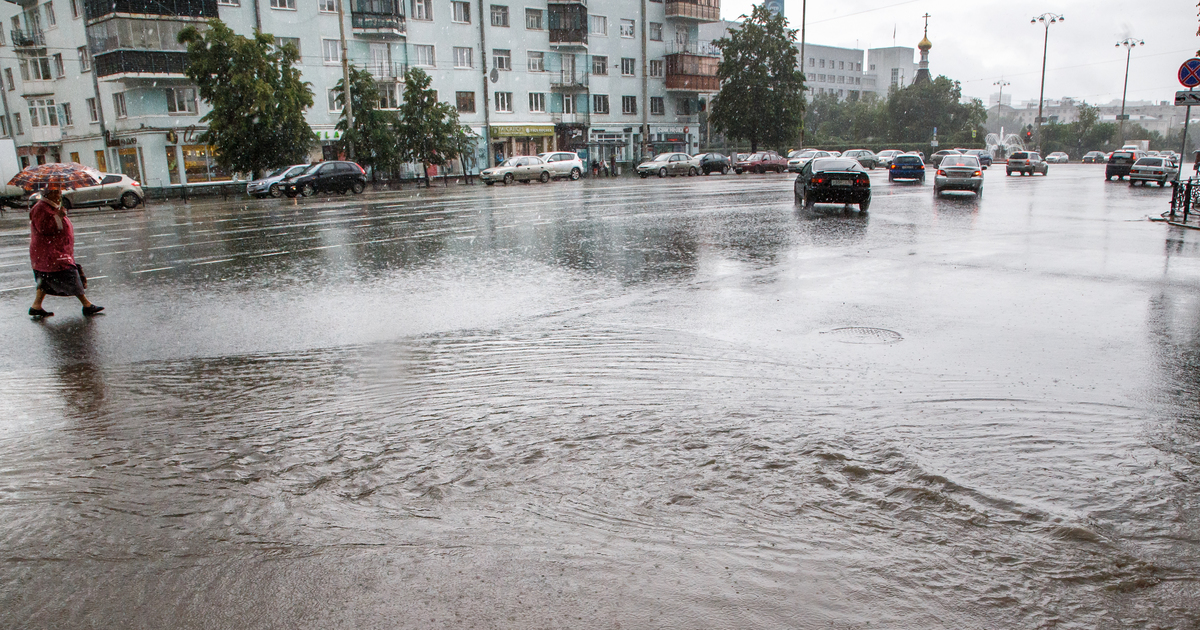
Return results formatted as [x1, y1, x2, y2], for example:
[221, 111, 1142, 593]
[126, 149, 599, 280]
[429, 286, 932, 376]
[179, 19, 317, 176]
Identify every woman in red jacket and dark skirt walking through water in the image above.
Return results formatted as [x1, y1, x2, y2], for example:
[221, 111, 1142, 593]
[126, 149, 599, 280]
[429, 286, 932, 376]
[29, 188, 104, 319]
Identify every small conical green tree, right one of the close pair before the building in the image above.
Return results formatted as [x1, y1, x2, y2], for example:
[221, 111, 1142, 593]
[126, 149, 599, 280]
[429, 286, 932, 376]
[397, 68, 475, 186]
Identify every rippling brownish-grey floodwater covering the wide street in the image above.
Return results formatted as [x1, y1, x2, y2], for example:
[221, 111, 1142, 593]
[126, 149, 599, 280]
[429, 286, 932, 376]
[0, 166, 1200, 630]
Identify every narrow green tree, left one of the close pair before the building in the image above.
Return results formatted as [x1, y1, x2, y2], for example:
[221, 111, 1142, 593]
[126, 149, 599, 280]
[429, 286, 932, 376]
[334, 66, 400, 179]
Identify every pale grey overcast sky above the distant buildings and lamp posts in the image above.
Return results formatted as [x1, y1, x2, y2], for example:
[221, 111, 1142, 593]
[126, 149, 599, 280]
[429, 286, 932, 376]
[721, 0, 1200, 106]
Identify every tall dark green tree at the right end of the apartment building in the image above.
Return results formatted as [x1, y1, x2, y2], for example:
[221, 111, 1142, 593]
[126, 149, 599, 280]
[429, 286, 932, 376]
[709, 5, 804, 151]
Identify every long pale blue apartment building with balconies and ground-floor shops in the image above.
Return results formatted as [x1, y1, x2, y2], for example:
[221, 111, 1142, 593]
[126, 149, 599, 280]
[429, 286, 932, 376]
[0, 0, 720, 187]
